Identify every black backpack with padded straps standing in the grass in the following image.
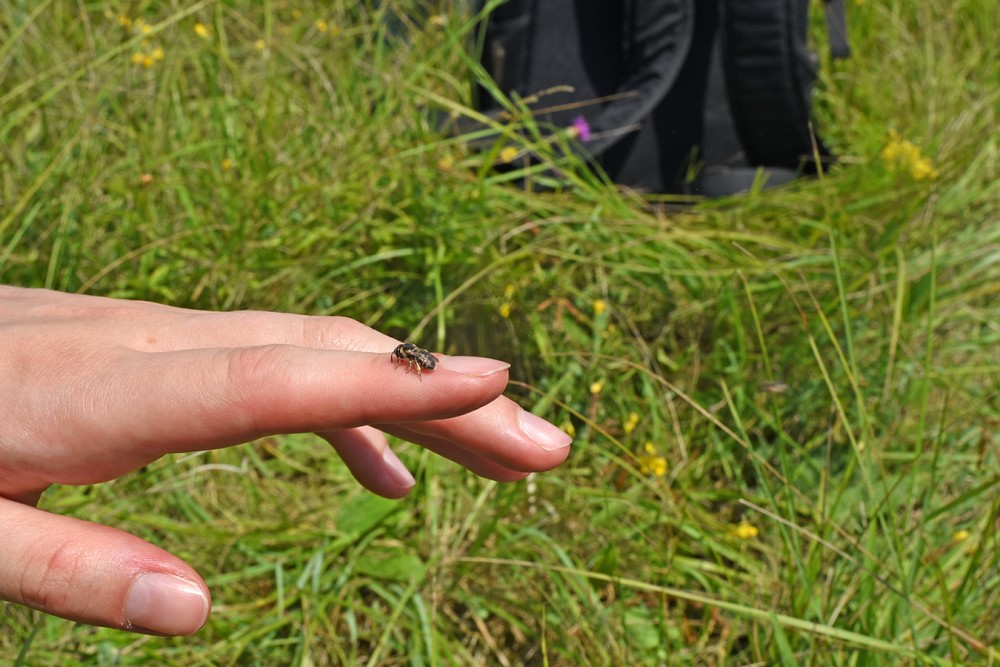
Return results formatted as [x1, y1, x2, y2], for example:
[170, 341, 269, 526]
[464, 0, 849, 196]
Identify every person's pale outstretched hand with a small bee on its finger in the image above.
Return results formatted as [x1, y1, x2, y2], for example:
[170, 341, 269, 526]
[0, 286, 570, 635]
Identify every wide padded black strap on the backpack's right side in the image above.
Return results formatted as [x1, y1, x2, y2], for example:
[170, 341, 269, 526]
[720, 0, 830, 172]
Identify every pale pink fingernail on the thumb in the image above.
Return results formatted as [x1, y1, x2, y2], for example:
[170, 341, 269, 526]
[125, 573, 208, 636]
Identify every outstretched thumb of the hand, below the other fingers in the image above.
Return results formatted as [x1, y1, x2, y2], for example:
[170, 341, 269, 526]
[0, 498, 211, 635]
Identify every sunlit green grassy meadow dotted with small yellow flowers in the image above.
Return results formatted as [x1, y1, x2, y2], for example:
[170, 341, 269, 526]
[0, 0, 1000, 667]
